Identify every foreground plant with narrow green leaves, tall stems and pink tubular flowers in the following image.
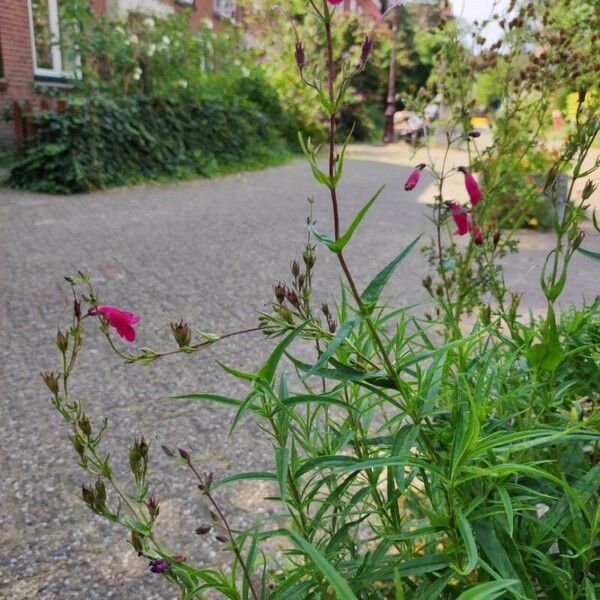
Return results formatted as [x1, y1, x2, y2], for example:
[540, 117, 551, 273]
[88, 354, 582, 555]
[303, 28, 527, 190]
[42, 0, 600, 600]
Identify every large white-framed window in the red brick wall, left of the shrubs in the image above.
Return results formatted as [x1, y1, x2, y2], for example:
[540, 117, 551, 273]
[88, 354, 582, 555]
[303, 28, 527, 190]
[29, 0, 77, 77]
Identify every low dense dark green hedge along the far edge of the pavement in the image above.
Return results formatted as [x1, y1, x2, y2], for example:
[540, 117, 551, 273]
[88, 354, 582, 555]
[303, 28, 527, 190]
[9, 78, 289, 193]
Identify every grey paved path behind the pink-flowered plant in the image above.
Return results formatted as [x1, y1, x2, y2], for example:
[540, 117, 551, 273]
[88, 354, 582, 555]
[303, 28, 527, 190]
[0, 154, 599, 600]
